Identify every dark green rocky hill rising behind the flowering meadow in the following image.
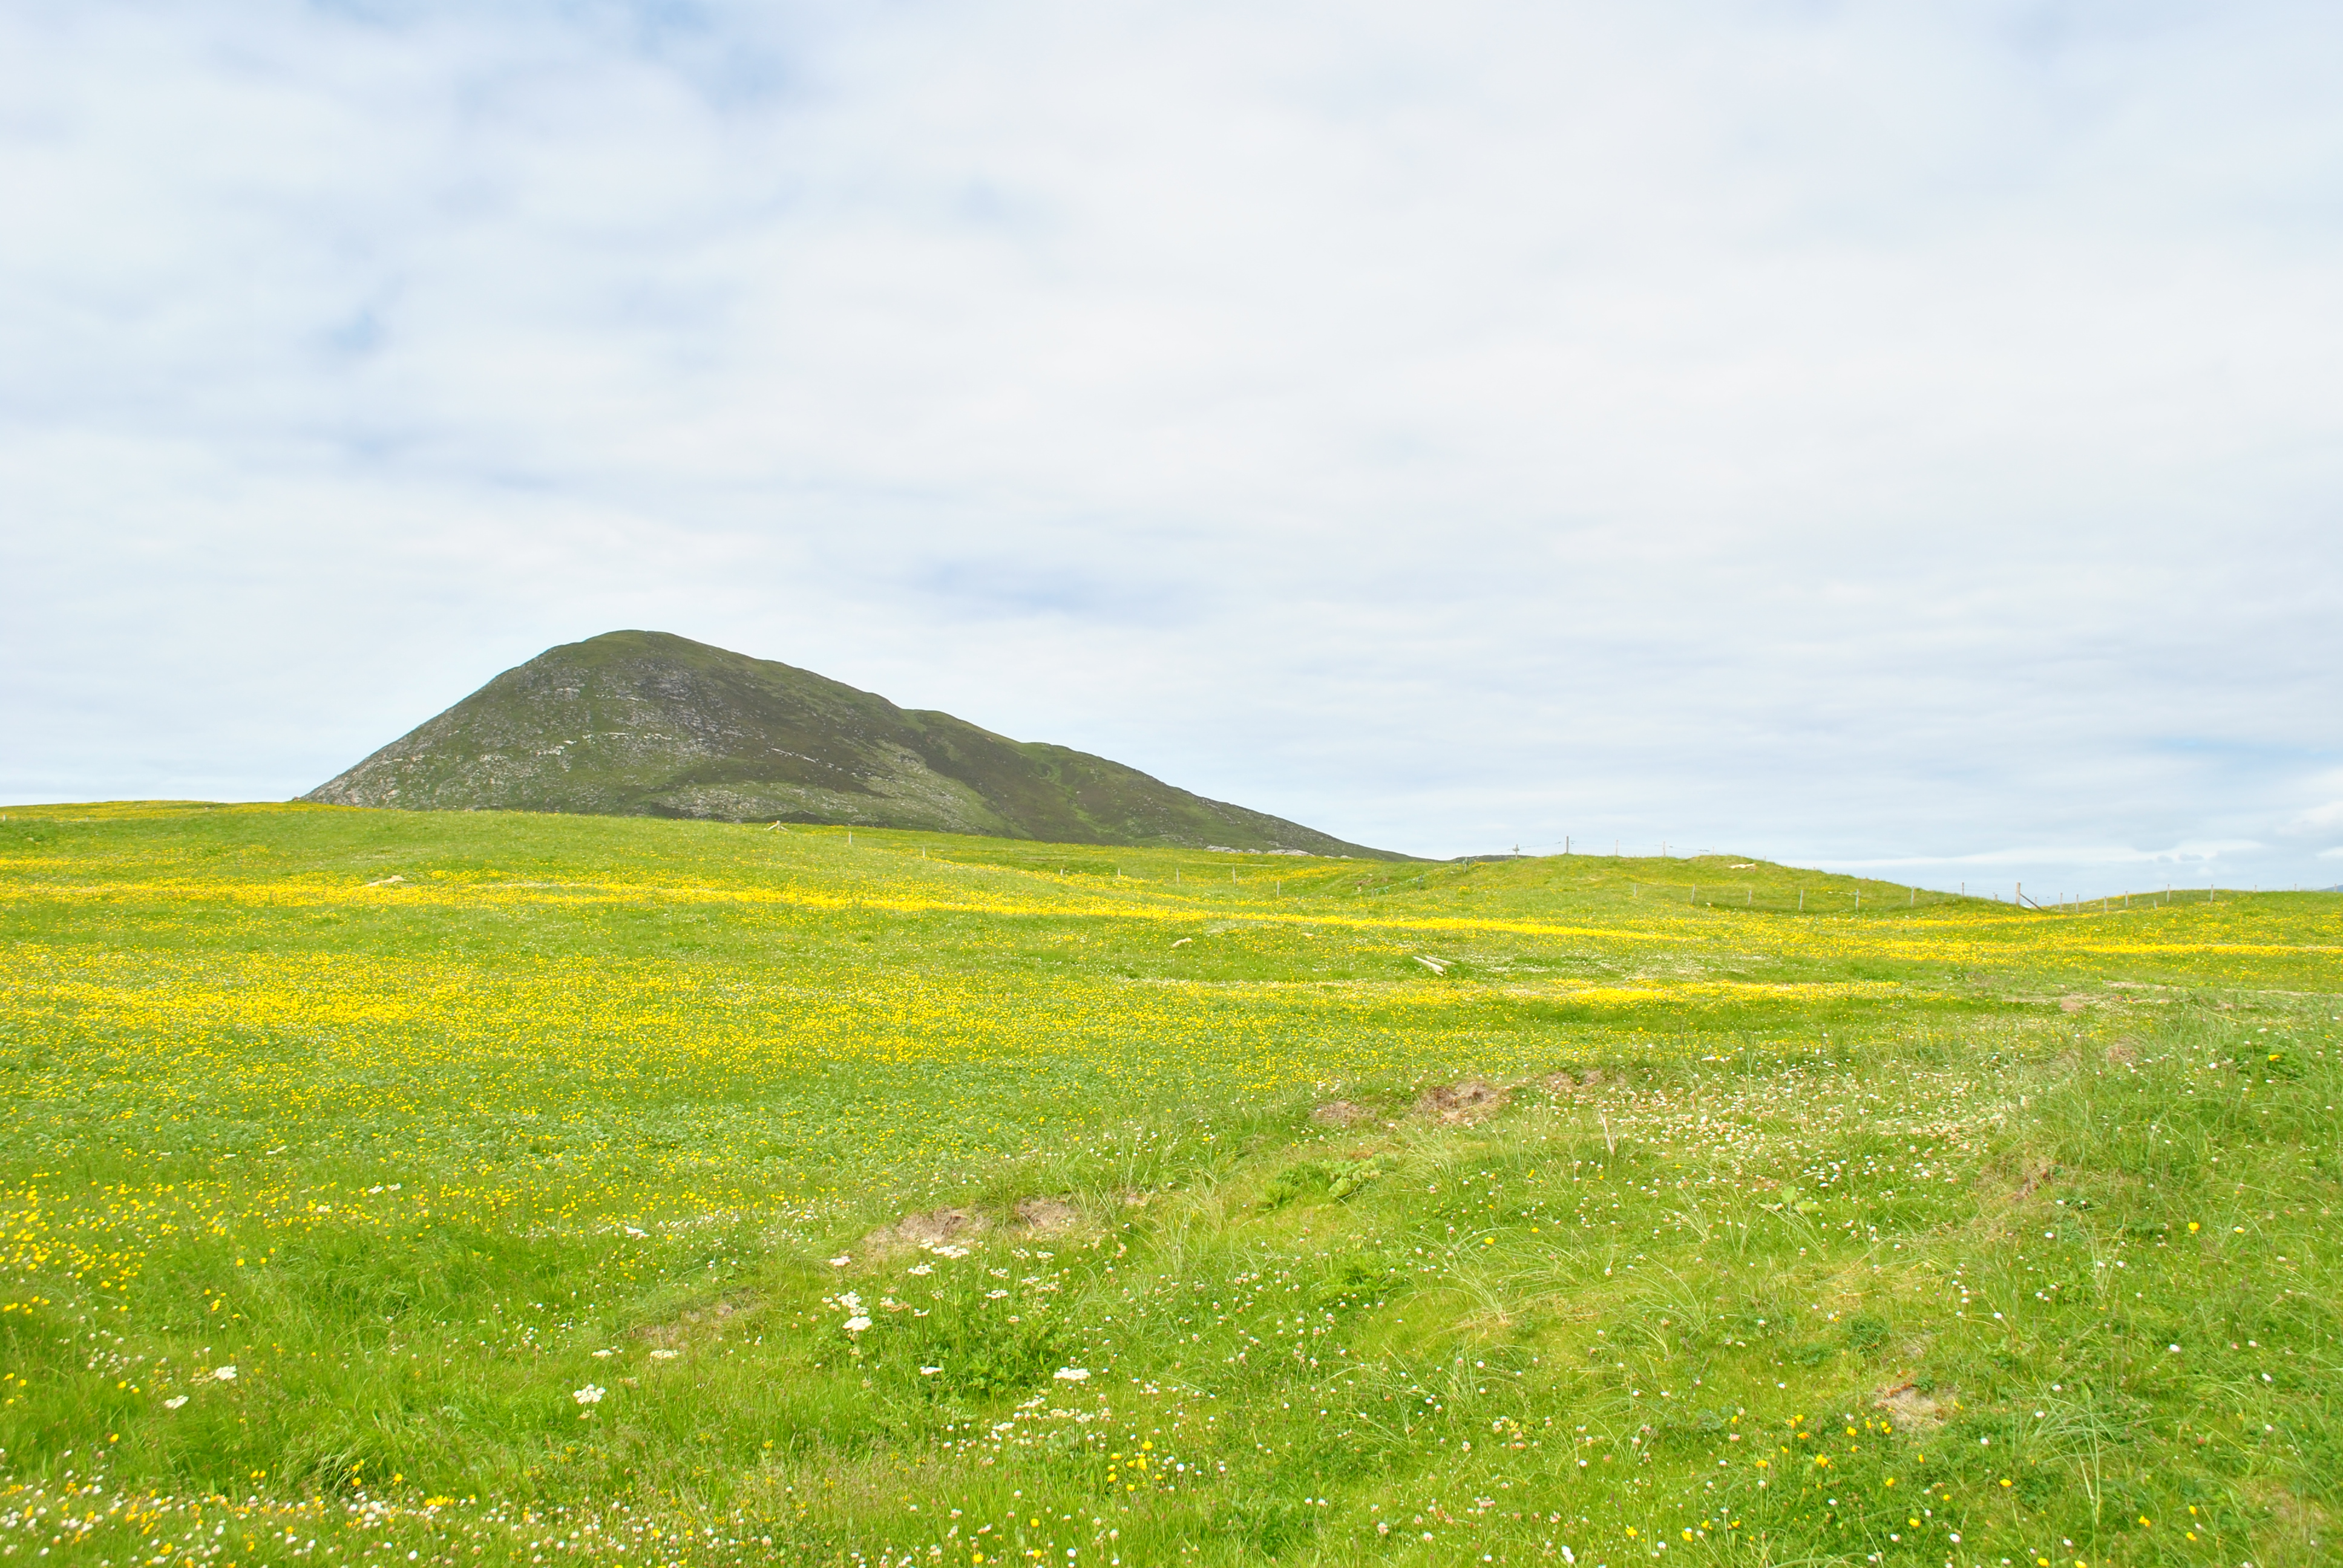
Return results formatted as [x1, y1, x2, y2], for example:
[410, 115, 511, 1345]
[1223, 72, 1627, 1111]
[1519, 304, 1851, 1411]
[302, 630, 1403, 860]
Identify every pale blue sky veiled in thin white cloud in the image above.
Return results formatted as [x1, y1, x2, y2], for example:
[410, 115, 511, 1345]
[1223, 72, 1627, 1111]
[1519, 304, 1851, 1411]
[0, 0, 2343, 898]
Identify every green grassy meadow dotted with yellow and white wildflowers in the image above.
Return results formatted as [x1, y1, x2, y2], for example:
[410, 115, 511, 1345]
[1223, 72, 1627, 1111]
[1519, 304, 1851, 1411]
[0, 804, 2343, 1568]
